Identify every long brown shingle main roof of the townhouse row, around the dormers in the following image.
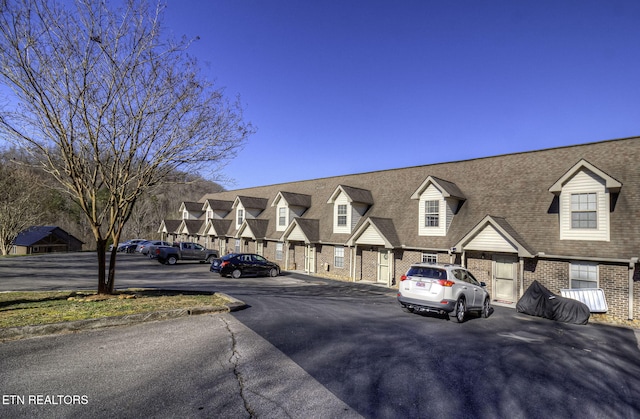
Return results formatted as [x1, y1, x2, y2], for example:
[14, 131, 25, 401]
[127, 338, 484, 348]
[195, 137, 640, 258]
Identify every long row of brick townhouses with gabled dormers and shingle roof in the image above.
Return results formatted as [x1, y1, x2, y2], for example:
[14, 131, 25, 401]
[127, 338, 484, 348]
[159, 137, 640, 319]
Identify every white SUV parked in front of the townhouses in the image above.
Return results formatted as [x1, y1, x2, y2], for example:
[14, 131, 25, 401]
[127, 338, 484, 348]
[398, 263, 491, 323]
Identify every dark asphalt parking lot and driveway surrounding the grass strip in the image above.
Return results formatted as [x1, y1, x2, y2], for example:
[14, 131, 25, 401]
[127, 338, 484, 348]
[0, 254, 640, 418]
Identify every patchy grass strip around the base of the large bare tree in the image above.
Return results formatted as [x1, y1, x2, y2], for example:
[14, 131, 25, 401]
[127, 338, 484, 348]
[0, 289, 229, 328]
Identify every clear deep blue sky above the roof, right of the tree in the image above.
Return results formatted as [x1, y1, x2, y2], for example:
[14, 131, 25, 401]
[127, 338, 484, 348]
[165, 0, 640, 189]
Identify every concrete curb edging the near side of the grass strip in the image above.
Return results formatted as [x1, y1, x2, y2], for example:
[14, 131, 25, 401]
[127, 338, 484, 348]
[0, 293, 247, 342]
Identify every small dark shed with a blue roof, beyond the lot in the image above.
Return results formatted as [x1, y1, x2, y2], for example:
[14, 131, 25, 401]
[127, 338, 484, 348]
[11, 226, 84, 255]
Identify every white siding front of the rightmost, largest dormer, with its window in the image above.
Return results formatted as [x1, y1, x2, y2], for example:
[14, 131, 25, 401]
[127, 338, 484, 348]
[560, 170, 609, 241]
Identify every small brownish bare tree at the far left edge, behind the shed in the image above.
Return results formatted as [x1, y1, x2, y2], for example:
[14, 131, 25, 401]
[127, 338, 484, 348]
[0, 154, 43, 255]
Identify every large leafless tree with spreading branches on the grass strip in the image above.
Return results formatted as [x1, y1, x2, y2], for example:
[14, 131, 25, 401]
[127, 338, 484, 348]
[0, 0, 253, 293]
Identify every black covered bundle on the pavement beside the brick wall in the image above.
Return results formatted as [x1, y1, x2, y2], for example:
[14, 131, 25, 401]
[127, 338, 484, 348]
[516, 281, 590, 324]
